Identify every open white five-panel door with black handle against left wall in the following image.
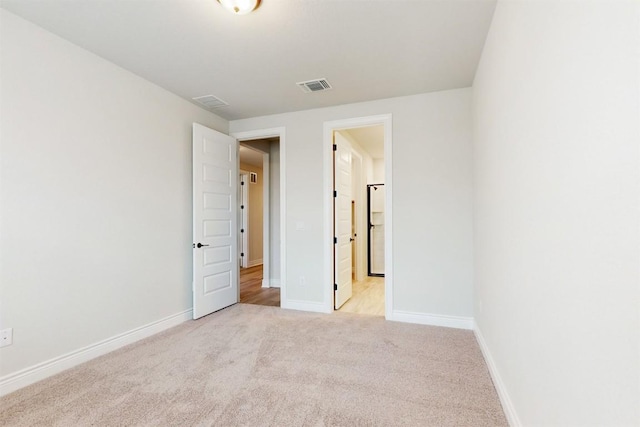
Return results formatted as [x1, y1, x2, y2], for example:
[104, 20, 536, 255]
[193, 123, 238, 319]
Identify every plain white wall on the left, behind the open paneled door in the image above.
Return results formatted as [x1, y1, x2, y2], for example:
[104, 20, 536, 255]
[0, 10, 228, 384]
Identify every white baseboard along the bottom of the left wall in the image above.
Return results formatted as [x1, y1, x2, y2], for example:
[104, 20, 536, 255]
[0, 309, 193, 396]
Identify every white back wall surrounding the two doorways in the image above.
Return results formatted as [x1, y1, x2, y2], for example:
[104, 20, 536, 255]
[229, 89, 472, 317]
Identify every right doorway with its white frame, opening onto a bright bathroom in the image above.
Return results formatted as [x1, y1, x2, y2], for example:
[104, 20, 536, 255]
[324, 115, 393, 318]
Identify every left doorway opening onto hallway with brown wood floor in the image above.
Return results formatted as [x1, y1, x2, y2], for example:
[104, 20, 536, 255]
[238, 137, 280, 306]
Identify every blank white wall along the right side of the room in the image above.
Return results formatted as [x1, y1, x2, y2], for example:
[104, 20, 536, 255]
[473, 1, 640, 426]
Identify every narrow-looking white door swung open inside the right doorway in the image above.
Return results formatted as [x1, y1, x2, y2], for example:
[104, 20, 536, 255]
[333, 132, 353, 310]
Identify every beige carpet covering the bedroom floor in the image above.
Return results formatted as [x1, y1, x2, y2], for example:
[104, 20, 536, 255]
[0, 304, 507, 426]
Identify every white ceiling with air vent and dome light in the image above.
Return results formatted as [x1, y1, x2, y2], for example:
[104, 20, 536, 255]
[0, 0, 495, 120]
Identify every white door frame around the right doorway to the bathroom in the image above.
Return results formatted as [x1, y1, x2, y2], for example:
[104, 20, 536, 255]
[322, 114, 393, 320]
